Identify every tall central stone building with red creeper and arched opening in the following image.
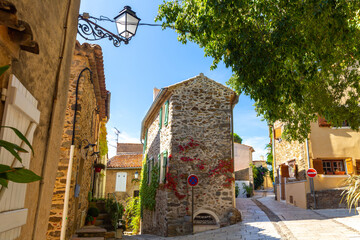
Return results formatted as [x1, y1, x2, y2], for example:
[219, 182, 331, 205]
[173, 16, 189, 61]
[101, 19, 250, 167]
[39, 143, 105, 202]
[140, 74, 239, 236]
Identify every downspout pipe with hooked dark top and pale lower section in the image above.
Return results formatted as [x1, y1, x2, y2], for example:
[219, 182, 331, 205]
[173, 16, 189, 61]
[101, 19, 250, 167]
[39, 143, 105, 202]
[60, 67, 93, 240]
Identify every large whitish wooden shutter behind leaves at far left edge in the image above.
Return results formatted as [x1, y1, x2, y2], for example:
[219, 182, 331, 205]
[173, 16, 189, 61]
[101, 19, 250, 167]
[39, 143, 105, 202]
[0, 75, 40, 240]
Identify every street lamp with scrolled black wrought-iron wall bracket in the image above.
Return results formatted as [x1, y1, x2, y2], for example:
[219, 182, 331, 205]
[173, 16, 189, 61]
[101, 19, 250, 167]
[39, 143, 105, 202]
[78, 6, 141, 47]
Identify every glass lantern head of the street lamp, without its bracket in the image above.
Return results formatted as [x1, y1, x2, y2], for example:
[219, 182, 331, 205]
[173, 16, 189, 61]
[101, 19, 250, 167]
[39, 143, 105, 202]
[115, 6, 140, 39]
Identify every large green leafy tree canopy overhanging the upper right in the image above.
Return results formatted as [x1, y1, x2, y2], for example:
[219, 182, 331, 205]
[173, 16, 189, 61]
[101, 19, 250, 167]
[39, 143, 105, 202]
[156, 0, 360, 140]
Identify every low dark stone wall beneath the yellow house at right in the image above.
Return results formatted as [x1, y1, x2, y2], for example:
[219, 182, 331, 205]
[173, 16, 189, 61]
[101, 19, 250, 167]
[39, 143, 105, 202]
[306, 189, 346, 209]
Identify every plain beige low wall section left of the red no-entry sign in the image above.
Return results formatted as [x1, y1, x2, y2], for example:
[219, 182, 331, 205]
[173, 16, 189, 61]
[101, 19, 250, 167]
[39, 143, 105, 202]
[285, 181, 307, 208]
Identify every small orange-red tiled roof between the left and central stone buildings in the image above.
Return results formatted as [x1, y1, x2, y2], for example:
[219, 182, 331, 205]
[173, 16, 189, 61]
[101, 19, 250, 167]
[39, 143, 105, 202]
[107, 154, 143, 168]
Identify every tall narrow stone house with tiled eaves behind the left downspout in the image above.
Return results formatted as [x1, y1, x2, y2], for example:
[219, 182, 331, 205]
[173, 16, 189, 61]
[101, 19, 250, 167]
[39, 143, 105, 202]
[47, 42, 110, 239]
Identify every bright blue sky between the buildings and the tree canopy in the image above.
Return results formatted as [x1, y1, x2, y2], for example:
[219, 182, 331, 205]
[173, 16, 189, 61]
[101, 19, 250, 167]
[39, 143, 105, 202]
[77, 0, 269, 160]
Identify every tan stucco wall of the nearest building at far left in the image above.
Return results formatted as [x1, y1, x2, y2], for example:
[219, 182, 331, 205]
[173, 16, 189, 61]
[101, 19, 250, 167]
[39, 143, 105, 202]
[0, 0, 80, 240]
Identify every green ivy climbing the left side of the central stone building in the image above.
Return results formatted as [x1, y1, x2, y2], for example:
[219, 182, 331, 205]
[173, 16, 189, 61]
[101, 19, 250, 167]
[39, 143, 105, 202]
[140, 158, 160, 210]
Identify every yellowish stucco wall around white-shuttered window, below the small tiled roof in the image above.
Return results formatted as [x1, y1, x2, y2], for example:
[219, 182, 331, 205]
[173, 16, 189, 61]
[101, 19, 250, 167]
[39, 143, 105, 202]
[105, 168, 141, 206]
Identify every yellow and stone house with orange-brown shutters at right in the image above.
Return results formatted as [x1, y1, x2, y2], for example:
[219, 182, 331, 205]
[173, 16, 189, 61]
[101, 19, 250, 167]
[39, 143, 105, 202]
[272, 117, 360, 208]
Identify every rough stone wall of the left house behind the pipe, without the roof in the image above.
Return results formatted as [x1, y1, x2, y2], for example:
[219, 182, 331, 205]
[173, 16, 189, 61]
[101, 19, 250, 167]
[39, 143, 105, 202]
[47, 53, 99, 239]
